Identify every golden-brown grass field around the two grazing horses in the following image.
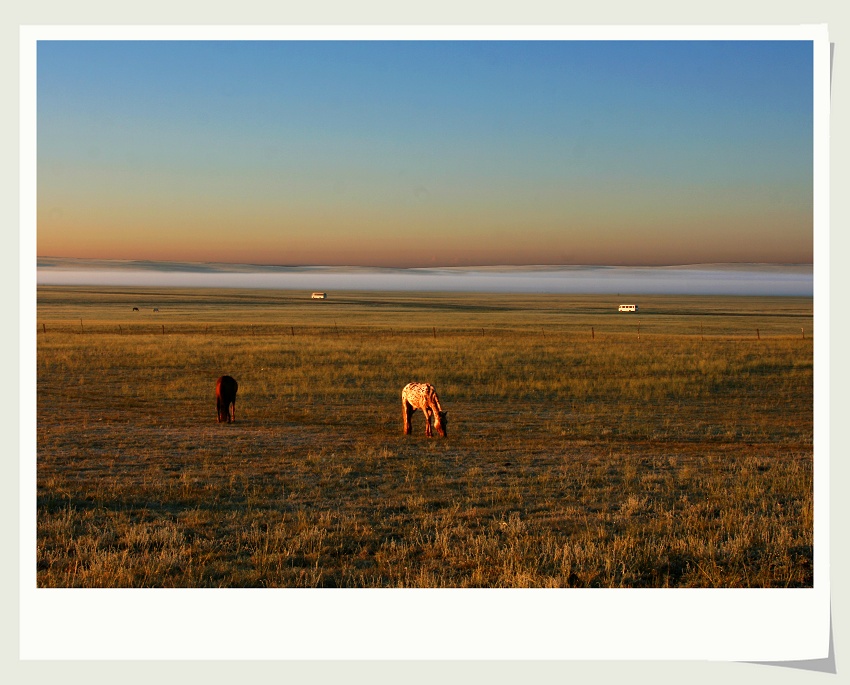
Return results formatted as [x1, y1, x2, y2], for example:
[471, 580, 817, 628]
[37, 287, 813, 587]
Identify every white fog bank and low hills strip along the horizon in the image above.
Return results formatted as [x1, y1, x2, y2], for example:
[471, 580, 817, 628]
[37, 258, 813, 297]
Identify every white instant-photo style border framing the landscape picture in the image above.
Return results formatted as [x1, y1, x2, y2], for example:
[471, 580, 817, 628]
[20, 25, 830, 662]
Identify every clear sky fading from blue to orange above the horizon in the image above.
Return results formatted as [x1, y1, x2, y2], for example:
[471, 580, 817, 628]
[37, 36, 813, 266]
